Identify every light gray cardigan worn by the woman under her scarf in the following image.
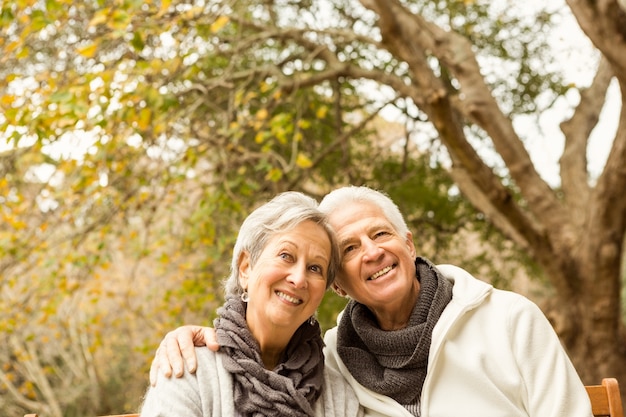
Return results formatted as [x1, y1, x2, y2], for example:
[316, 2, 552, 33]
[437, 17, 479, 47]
[136, 347, 363, 417]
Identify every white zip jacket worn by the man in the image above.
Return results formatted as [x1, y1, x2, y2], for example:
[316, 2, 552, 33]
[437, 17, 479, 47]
[324, 265, 592, 417]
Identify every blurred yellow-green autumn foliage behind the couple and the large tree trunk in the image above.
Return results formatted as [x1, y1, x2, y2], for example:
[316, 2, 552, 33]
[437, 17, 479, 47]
[0, 0, 620, 417]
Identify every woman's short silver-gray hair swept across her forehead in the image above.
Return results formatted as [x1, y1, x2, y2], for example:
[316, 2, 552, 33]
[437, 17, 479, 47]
[224, 191, 341, 296]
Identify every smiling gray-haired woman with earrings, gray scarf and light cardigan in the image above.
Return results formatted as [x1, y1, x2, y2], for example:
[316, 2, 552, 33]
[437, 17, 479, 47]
[141, 192, 362, 416]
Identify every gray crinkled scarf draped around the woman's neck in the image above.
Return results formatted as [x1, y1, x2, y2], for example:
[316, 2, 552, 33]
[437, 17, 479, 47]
[214, 297, 324, 417]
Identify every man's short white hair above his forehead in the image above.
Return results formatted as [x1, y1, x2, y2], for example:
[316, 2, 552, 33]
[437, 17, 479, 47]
[319, 185, 409, 236]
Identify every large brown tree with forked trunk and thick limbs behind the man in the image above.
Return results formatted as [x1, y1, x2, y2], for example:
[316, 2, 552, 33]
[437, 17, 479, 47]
[362, 0, 626, 398]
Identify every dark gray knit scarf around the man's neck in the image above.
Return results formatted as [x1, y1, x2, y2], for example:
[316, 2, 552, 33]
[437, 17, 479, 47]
[337, 258, 452, 415]
